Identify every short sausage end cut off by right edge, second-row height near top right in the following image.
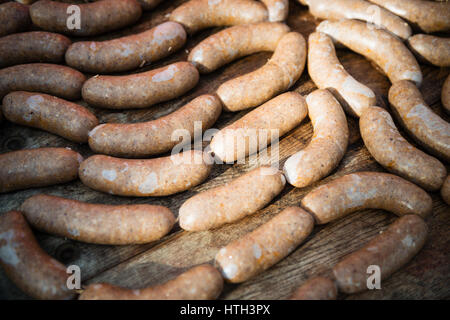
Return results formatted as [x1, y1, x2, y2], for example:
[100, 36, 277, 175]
[408, 34, 450, 67]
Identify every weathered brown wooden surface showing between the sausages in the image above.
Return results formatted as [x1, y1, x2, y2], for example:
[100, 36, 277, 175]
[0, 0, 450, 299]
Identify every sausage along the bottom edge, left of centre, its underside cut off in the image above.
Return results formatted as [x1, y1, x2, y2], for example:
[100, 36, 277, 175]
[79, 264, 223, 300]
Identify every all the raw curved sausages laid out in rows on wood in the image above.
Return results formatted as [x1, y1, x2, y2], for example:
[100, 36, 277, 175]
[0, 0, 450, 299]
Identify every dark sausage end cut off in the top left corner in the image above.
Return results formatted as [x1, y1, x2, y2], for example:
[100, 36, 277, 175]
[0, 2, 31, 37]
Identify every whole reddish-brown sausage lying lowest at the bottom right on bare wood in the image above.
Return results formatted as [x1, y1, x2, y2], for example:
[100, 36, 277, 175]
[333, 215, 428, 293]
